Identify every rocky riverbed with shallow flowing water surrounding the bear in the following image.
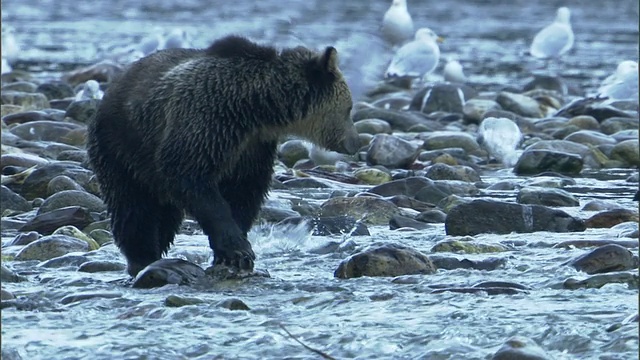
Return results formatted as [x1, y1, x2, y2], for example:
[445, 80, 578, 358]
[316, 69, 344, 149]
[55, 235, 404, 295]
[0, 1, 640, 359]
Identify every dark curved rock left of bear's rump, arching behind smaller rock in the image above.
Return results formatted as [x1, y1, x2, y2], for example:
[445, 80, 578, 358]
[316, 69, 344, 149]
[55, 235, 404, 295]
[20, 162, 93, 200]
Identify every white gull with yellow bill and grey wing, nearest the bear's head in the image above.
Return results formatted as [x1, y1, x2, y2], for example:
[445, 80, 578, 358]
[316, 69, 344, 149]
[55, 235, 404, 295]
[387, 28, 443, 78]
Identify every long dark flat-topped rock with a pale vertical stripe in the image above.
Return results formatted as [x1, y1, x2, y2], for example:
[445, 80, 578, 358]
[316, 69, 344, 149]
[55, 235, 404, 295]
[445, 200, 585, 236]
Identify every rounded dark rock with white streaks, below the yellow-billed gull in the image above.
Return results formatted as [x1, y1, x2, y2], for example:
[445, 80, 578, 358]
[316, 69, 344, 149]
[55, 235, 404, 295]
[409, 84, 475, 114]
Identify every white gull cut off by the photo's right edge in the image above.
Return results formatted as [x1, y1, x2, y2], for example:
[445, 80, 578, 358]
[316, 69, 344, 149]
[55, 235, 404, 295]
[598, 60, 638, 102]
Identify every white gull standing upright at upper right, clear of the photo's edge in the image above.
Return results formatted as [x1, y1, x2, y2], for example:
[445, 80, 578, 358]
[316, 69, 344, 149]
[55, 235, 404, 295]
[529, 7, 573, 59]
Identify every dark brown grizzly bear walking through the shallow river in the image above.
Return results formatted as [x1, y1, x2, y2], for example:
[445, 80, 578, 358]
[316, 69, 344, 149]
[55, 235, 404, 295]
[87, 36, 360, 276]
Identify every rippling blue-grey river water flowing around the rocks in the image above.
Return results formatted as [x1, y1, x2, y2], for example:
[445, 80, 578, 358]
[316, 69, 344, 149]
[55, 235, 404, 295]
[2, 0, 638, 360]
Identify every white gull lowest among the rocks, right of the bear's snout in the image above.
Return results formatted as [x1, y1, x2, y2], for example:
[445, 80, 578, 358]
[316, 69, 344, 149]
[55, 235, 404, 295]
[478, 117, 522, 167]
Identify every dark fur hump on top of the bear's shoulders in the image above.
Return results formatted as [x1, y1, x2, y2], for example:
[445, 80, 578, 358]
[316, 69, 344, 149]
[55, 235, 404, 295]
[206, 35, 278, 61]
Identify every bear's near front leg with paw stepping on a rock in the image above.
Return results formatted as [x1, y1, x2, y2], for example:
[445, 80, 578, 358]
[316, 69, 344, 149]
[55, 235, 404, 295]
[188, 187, 256, 271]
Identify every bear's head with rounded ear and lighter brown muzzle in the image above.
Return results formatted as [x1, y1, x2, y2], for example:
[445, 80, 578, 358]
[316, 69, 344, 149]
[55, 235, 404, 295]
[294, 46, 360, 154]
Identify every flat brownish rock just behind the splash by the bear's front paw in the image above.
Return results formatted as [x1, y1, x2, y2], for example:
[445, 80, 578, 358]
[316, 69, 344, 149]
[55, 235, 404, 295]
[320, 196, 400, 225]
